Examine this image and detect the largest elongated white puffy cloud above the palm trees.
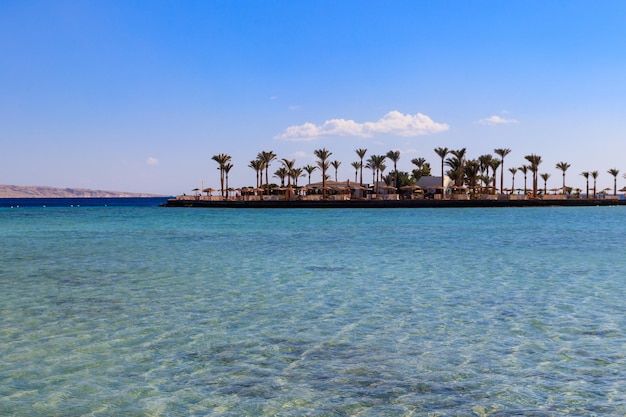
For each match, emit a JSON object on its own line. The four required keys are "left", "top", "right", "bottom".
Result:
{"left": 274, "top": 110, "right": 448, "bottom": 141}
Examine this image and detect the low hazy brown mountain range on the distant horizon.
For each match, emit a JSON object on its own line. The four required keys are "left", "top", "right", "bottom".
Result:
{"left": 0, "top": 184, "right": 163, "bottom": 198}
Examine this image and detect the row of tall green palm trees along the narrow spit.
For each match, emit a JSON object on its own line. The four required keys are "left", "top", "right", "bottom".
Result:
{"left": 211, "top": 147, "right": 626, "bottom": 198}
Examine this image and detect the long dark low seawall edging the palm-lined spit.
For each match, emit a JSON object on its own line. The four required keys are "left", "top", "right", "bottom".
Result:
{"left": 161, "top": 198, "right": 626, "bottom": 209}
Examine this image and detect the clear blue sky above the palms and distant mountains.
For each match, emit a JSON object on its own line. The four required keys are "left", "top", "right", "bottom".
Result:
{"left": 0, "top": 0, "right": 626, "bottom": 194}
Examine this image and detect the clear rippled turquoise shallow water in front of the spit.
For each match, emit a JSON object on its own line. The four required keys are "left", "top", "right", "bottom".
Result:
{"left": 0, "top": 203, "right": 626, "bottom": 416}
